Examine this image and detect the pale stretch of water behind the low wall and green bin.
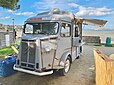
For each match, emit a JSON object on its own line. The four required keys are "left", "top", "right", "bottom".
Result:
{"left": 82, "top": 30, "right": 114, "bottom": 44}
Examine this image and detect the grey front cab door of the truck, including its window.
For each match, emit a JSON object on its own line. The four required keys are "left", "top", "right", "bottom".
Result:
{"left": 56, "top": 23, "right": 71, "bottom": 59}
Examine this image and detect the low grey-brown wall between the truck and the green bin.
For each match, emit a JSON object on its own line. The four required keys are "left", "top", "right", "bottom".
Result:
{"left": 82, "top": 36, "right": 100, "bottom": 43}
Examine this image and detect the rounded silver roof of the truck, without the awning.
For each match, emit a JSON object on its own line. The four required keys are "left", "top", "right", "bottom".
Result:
{"left": 27, "top": 9, "right": 75, "bottom": 22}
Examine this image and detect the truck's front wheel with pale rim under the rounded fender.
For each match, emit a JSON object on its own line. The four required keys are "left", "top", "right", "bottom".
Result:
{"left": 59, "top": 57, "right": 71, "bottom": 76}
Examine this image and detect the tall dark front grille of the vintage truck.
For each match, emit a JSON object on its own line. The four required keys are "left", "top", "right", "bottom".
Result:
{"left": 21, "top": 40, "right": 36, "bottom": 67}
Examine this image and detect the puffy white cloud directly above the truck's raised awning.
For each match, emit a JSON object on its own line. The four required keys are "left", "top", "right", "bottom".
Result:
{"left": 76, "top": 6, "right": 112, "bottom": 16}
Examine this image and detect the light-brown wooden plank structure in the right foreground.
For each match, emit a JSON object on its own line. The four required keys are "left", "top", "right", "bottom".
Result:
{"left": 94, "top": 49, "right": 114, "bottom": 85}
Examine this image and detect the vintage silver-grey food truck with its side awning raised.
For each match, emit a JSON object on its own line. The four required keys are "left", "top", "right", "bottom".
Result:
{"left": 14, "top": 9, "right": 107, "bottom": 76}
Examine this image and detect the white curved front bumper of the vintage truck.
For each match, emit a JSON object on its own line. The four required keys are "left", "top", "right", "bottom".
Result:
{"left": 13, "top": 65, "right": 53, "bottom": 76}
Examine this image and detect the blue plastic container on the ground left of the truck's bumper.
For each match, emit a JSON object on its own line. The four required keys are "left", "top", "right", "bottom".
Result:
{"left": 0, "top": 57, "right": 16, "bottom": 77}
